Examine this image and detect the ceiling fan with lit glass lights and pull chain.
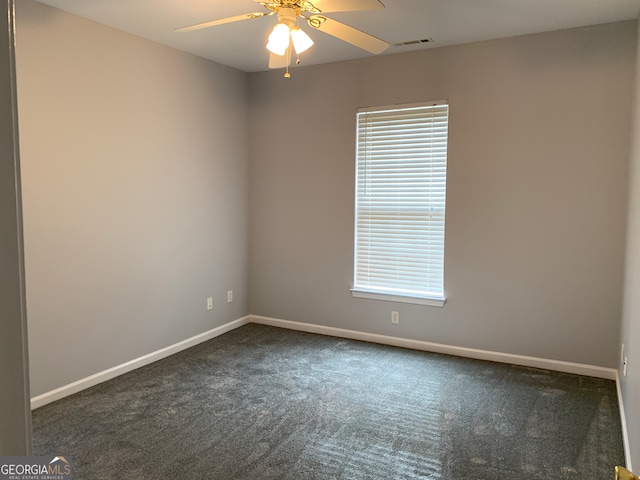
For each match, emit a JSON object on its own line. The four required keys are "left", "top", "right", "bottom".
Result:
{"left": 176, "top": 0, "right": 389, "bottom": 78}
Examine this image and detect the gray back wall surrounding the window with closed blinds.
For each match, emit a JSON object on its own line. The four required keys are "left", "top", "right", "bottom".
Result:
{"left": 249, "top": 21, "right": 636, "bottom": 368}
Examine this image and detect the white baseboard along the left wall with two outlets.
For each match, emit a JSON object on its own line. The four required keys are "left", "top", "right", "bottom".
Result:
{"left": 31, "top": 316, "right": 250, "bottom": 410}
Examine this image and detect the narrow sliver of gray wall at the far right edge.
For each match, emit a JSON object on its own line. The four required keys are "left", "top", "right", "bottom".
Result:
{"left": 620, "top": 21, "right": 640, "bottom": 474}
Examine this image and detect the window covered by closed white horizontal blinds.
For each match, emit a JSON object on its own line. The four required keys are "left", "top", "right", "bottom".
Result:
{"left": 352, "top": 102, "right": 449, "bottom": 306}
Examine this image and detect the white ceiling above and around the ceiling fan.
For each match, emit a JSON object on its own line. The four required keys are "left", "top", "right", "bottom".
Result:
{"left": 33, "top": 0, "right": 640, "bottom": 72}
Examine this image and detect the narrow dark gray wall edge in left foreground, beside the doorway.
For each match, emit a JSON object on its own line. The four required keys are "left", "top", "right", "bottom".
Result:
{"left": 0, "top": 0, "right": 31, "bottom": 456}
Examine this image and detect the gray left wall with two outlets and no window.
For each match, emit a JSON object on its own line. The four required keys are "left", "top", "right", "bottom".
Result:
{"left": 17, "top": 0, "right": 248, "bottom": 396}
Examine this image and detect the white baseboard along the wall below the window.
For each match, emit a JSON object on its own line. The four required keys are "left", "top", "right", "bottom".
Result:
{"left": 250, "top": 315, "right": 617, "bottom": 380}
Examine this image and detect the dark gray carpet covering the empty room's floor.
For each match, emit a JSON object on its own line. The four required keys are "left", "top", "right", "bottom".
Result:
{"left": 33, "top": 324, "right": 624, "bottom": 480}
